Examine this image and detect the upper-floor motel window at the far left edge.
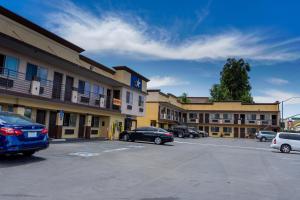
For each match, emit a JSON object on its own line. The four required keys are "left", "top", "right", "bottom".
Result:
{"left": 0, "top": 54, "right": 19, "bottom": 78}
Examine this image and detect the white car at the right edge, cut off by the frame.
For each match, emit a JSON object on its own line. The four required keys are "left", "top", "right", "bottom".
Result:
{"left": 271, "top": 132, "right": 300, "bottom": 153}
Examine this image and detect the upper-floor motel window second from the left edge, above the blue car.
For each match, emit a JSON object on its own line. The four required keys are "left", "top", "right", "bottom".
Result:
{"left": 25, "top": 63, "right": 48, "bottom": 85}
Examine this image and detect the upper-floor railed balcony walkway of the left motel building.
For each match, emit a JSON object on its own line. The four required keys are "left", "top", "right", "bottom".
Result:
{"left": 0, "top": 68, "right": 120, "bottom": 111}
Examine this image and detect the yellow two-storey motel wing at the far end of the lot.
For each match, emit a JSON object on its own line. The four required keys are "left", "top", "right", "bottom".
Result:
{"left": 137, "top": 90, "right": 280, "bottom": 138}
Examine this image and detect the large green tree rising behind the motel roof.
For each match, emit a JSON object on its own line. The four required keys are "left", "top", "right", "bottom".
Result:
{"left": 210, "top": 58, "right": 253, "bottom": 103}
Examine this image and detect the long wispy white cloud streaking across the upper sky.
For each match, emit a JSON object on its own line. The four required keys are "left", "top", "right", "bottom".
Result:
{"left": 47, "top": 2, "right": 300, "bottom": 61}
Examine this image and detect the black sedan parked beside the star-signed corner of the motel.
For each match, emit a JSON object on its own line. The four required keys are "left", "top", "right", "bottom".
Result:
{"left": 119, "top": 127, "right": 174, "bottom": 144}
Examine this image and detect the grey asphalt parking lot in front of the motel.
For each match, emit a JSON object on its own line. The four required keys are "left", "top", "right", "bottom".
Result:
{"left": 0, "top": 138, "right": 300, "bottom": 200}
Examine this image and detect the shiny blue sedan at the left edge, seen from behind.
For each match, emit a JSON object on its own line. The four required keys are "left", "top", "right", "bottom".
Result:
{"left": 0, "top": 112, "right": 49, "bottom": 156}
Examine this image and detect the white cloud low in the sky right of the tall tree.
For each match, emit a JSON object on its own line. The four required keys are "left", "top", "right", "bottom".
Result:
{"left": 253, "top": 89, "right": 300, "bottom": 104}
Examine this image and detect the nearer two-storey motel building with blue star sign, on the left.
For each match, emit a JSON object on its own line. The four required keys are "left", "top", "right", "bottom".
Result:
{"left": 0, "top": 6, "right": 149, "bottom": 139}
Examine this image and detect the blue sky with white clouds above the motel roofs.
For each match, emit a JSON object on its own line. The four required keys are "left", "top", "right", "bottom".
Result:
{"left": 0, "top": 0, "right": 300, "bottom": 116}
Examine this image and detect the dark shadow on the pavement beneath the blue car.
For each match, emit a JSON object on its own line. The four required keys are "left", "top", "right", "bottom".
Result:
{"left": 0, "top": 154, "right": 46, "bottom": 168}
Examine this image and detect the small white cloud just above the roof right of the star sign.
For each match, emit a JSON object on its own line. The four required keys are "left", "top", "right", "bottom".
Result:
{"left": 147, "top": 76, "right": 189, "bottom": 88}
